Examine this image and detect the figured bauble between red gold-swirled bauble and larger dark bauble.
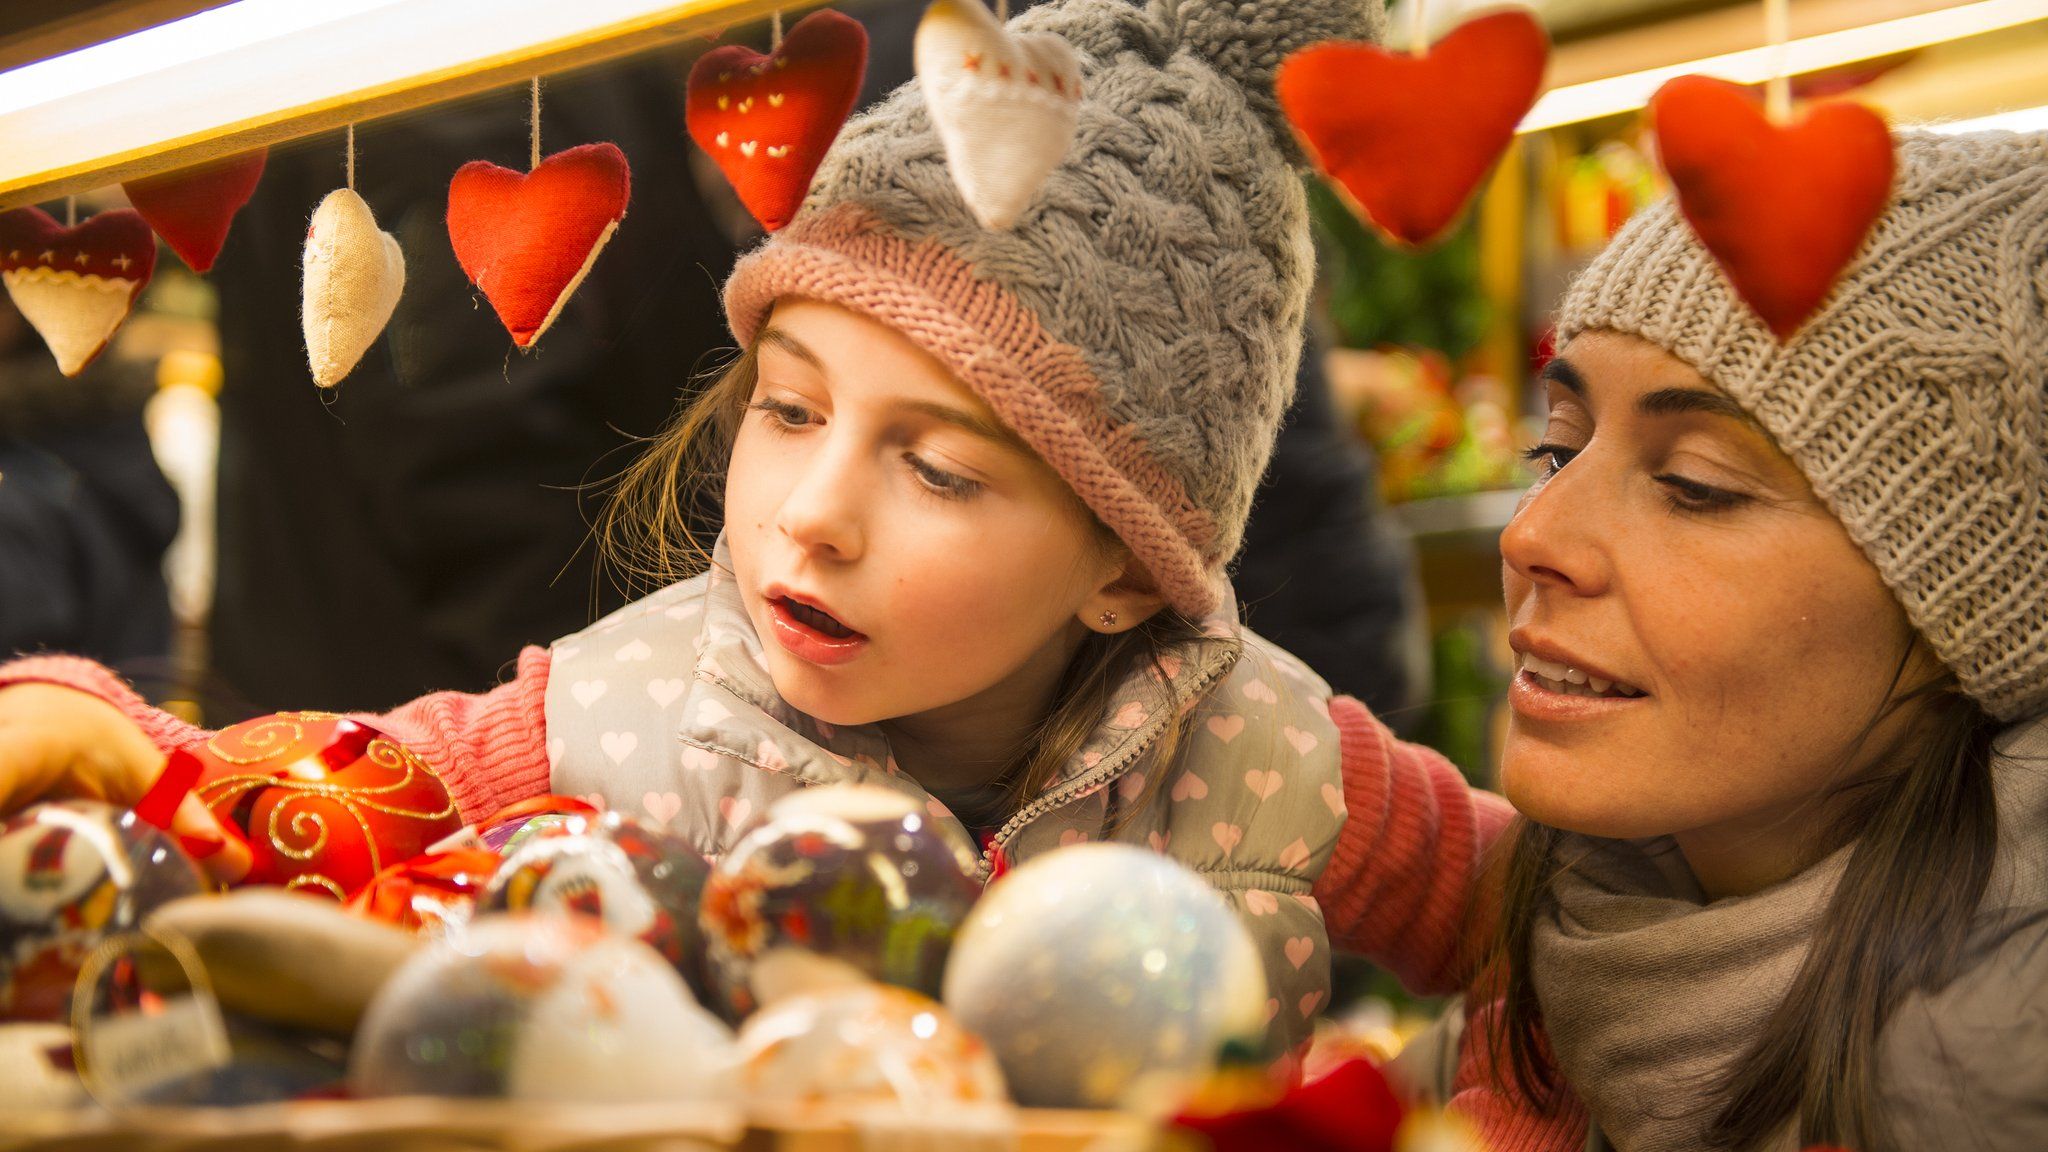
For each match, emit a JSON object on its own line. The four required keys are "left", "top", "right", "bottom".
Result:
{"left": 477, "top": 812, "right": 711, "bottom": 994}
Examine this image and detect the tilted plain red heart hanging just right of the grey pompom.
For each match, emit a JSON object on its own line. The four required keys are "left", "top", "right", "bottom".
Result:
{"left": 1274, "top": 8, "right": 1550, "bottom": 246}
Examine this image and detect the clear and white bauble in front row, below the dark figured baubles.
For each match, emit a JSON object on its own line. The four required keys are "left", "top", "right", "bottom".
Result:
{"left": 348, "top": 916, "right": 735, "bottom": 1103}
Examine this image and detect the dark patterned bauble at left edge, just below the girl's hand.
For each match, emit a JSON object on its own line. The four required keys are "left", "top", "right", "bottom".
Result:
{"left": 0, "top": 799, "right": 207, "bottom": 1021}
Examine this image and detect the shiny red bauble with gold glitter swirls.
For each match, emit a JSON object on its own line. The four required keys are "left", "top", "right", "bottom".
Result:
{"left": 166, "top": 711, "right": 463, "bottom": 900}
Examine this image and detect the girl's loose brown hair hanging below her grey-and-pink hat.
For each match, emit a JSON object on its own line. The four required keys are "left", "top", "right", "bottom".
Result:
{"left": 596, "top": 348, "right": 1228, "bottom": 828}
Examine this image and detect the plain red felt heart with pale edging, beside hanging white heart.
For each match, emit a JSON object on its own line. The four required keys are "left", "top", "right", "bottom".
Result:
{"left": 449, "top": 143, "right": 633, "bottom": 348}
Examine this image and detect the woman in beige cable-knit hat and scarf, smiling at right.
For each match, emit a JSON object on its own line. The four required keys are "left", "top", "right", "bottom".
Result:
{"left": 1317, "top": 133, "right": 2048, "bottom": 1152}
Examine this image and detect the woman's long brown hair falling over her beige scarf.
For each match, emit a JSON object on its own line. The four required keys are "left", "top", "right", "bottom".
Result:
{"left": 1481, "top": 648, "right": 1999, "bottom": 1152}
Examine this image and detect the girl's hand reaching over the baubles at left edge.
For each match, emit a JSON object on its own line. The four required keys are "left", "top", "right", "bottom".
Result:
{"left": 0, "top": 685, "right": 250, "bottom": 883}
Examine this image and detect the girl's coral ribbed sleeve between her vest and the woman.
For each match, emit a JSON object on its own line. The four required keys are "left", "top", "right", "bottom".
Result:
{"left": 1315, "top": 697, "right": 1513, "bottom": 994}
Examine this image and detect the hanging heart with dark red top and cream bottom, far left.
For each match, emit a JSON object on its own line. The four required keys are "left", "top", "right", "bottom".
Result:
{"left": 0, "top": 207, "right": 156, "bottom": 375}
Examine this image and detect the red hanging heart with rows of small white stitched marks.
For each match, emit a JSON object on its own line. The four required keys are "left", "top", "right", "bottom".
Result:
{"left": 684, "top": 8, "right": 868, "bottom": 232}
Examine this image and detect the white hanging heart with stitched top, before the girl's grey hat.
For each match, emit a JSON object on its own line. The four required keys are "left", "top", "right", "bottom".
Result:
{"left": 915, "top": 0, "right": 1081, "bottom": 228}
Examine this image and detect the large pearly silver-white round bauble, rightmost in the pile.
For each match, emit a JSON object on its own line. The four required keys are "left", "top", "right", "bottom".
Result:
{"left": 946, "top": 845, "right": 1266, "bottom": 1107}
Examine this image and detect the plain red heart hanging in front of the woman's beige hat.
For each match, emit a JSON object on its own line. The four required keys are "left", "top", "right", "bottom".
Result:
{"left": 1651, "top": 76, "right": 1896, "bottom": 340}
